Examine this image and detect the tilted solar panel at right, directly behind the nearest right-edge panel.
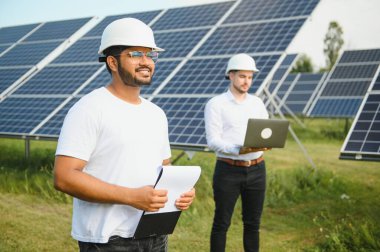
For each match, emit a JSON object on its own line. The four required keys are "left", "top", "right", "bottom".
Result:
{"left": 307, "top": 49, "right": 380, "bottom": 117}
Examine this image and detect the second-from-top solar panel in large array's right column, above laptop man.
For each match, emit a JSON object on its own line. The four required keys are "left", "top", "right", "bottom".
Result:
{"left": 196, "top": 19, "right": 305, "bottom": 55}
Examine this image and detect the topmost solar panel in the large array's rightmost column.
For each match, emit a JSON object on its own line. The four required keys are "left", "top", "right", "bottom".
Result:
{"left": 224, "top": 0, "right": 319, "bottom": 23}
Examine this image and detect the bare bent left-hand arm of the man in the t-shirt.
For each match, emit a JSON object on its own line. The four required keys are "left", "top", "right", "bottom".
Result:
{"left": 54, "top": 155, "right": 167, "bottom": 212}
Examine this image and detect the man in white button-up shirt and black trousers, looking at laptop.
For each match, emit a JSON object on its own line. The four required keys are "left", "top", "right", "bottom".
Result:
{"left": 205, "top": 54, "right": 268, "bottom": 252}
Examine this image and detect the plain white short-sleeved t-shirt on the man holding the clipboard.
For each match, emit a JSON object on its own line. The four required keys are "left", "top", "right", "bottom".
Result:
{"left": 56, "top": 87, "right": 171, "bottom": 243}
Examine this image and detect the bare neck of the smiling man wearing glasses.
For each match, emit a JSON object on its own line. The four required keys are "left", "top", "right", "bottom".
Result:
{"left": 107, "top": 82, "right": 141, "bottom": 105}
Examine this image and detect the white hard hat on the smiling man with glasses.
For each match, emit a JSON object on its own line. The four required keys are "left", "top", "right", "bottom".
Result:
{"left": 98, "top": 18, "right": 164, "bottom": 55}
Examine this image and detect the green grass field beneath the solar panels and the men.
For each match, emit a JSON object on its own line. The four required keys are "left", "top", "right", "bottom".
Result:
{"left": 0, "top": 119, "right": 380, "bottom": 252}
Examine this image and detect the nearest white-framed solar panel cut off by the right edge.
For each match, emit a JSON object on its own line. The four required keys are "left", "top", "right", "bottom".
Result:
{"left": 339, "top": 72, "right": 380, "bottom": 161}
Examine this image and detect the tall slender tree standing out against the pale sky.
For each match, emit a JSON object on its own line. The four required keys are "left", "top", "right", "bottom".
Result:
{"left": 323, "top": 21, "right": 344, "bottom": 71}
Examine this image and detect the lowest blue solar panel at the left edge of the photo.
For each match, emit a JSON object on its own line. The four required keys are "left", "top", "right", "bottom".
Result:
{"left": 0, "top": 97, "right": 64, "bottom": 134}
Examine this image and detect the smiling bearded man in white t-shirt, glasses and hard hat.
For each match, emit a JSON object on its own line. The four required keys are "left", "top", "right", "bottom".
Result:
{"left": 54, "top": 18, "right": 195, "bottom": 251}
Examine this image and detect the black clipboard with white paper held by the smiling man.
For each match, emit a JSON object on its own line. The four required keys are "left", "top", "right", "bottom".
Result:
{"left": 133, "top": 166, "right": 201, "bottom": 239}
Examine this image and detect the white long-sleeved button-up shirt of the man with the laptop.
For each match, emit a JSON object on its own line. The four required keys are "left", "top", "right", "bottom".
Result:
{"left": 205, "top": 87, "right": 269, "bottom": 160}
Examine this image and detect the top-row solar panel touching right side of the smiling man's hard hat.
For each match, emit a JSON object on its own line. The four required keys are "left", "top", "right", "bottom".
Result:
{"left": 153, "top": 2, "right": 234, "bottom": 31}
